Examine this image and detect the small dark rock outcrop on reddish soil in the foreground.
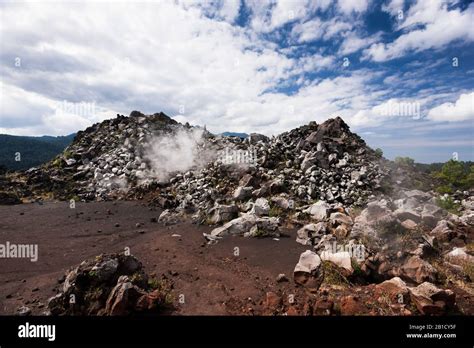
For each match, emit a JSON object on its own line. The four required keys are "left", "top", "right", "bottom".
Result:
{"left": 48, "top": 254, "right": 171, "bottom": 315}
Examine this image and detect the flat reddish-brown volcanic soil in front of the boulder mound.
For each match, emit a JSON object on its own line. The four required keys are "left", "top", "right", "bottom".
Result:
{"left": 0, "top": 201, "right": 306, "bottom": 315}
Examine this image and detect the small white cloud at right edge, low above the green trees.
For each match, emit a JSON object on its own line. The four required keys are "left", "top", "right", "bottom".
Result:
{"left": 428, "top": 92, "right": 474, "bottom": 122}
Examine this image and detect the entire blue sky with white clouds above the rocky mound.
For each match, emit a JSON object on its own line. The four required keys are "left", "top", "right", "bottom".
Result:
{"left": 0, "top": 0, "right": 474, "bottom": 162}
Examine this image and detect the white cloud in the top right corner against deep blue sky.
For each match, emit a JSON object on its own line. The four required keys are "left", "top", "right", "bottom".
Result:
{"left": 364, "top": 0, "right": 474, "bottom": 62}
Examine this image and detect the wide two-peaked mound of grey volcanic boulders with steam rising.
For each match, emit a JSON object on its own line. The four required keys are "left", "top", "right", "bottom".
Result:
{"left": 2, "top": 111, "right": 386, "bottom": 211}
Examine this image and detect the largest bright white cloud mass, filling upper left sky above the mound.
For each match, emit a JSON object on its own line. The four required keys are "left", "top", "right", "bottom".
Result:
{"left": 0, "top": 2, "right": 362, "bottom": 135}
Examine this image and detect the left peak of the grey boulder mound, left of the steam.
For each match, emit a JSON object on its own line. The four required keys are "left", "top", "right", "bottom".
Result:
{"left": 22, "top": 111, "right": 185, "bottom": 200}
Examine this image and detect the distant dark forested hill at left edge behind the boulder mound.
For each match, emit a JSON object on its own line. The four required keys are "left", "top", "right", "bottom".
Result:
{"left": 0, "top": 134, "right": 75, "bottom": 170}
